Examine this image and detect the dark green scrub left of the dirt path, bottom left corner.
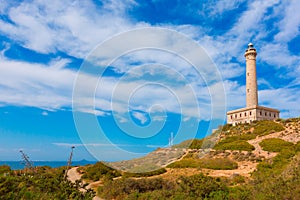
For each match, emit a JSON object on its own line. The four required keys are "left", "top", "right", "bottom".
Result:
{"left": 0, "top": 166, "right": 95, "bottom": 200}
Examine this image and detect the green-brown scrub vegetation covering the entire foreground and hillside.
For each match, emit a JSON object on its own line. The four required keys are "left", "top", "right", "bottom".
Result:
{"left": 0, "top": 118, "right": 300, "bottom": 200}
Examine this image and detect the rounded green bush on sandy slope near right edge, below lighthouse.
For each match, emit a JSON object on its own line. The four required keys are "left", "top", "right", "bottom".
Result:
{"left": 259, "top": 138, "right": 293, "bottom": 152}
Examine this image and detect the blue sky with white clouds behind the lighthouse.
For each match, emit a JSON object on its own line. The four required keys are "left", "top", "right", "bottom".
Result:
{"left": 0, "top": 0, "right": 300, "bottom": 160}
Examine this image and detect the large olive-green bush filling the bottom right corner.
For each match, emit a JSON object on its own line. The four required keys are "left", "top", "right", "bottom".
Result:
{"left": 249, "top": 150, "right": 300, "bottom": 199}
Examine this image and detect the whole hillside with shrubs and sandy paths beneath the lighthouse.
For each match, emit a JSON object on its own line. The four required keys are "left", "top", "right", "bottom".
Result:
{"left": 80, "top": 118, "right": 300, "bottom": 199}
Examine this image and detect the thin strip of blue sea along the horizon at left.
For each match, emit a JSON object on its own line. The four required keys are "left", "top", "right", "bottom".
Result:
{"left": 0, "top": 160, "right": 96, "bottom": 170}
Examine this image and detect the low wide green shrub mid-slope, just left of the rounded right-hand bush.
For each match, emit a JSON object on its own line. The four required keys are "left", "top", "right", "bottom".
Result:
{"left": 214, "top": 140, "right": 255, "bottom": 151}
